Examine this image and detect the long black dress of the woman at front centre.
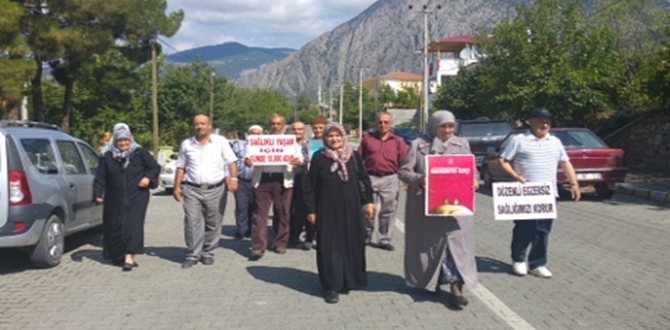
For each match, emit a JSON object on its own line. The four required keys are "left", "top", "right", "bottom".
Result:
{"left": 303, "top": 152, "right": 372, "bottom": 292}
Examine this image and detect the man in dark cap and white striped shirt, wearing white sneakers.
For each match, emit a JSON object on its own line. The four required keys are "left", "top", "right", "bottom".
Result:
{"left": 499, "top": 108, "right": 581, "bottom": 278}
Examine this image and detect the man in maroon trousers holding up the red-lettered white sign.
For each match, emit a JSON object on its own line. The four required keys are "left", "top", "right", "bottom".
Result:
{"left": 244, "top": 114, "right": 303, "bottom": 260}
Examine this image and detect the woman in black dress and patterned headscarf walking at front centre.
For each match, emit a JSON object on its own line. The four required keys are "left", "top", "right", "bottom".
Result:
{"left": 303, "top": 123, "right": 374, "bottom": 304}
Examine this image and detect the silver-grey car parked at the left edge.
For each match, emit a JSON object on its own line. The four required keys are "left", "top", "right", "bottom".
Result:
{"left": 0, "top": 121, "right": 102, "bottom": 267}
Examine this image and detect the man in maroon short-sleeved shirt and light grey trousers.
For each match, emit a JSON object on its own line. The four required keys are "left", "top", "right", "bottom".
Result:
{"left": 358, "top": 112, "right": 407, "bottom": 251}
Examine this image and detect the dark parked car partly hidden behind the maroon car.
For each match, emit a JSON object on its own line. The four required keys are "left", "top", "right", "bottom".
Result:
{"left": 454, "top": 117, "right": 514, "bottom": 170}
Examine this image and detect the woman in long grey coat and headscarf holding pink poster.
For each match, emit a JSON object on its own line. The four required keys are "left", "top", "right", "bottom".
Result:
{"left": 399, "top": 110, "right": 479, "bottom": 306}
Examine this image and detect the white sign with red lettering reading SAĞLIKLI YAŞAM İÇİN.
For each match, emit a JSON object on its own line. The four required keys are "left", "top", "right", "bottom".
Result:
{"left": 247, "top": 135, "right": 298, "bottom": 166}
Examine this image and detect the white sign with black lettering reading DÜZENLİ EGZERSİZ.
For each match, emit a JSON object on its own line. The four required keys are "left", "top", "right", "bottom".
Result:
{"left": 492, "top": 182, "right": 556, "bottom": 220}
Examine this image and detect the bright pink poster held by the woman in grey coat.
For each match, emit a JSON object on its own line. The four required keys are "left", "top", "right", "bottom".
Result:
{"left": 425, "top": 155, "right": 475, "bottom": 217}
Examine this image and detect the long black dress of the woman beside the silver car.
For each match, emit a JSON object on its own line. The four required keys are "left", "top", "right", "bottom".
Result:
{"left": 94, "top": 148, "right": 160, "bottom": 261}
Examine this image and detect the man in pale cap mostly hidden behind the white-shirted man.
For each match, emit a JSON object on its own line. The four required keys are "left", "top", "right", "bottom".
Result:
{"left": 230, "top": 125, "right": 263, "bottom": 239}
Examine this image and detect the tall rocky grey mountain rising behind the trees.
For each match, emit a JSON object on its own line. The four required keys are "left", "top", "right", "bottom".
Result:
{"left": 238, "top": 0, "right": 532, "bottom": 95}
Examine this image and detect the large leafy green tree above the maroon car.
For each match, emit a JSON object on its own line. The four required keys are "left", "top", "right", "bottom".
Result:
{"left": 478, "top": 0, "right": 623, "bottom": 123}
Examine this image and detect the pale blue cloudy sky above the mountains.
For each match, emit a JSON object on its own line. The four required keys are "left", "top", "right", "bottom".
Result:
{"left": 161, "top": 0, "right": 376, "bottom": 53}
